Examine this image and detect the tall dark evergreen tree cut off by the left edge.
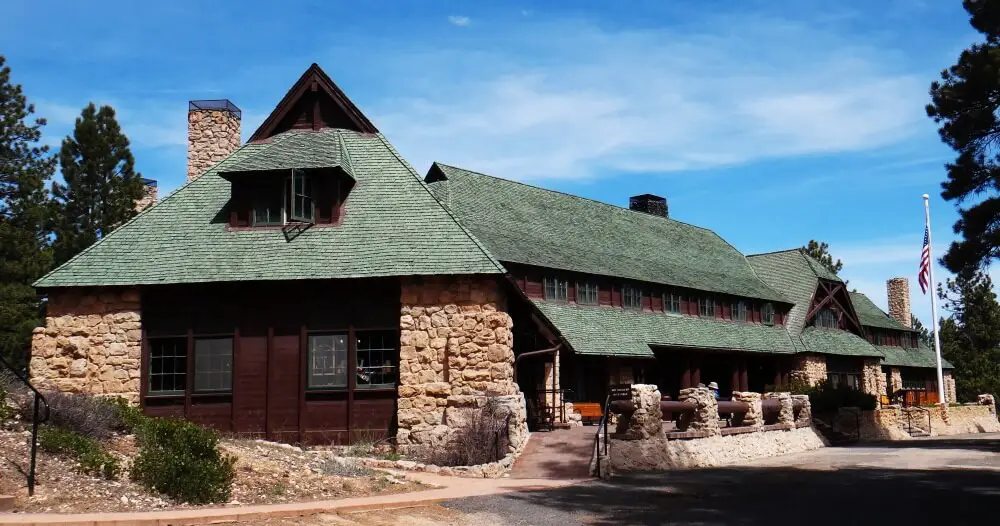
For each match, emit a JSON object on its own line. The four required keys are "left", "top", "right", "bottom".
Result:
{"left": 0, "top": 55, "right": 55, "bottom": 366}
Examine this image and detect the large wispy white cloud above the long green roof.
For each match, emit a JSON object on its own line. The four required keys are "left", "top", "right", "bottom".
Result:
{"left": 372, "top": 19, "right": 926, "bottom": 179}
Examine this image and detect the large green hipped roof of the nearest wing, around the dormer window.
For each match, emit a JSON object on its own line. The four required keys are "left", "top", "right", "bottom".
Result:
{"left": 35, "top": 129, "right": 503, "bottom": 287}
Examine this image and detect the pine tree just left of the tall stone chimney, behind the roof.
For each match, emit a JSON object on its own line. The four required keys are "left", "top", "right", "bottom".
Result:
{"left": 52, "top": 103, "right": 144, "bottom": 264}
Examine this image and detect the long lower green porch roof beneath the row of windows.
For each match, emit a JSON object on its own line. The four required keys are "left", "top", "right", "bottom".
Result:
{"left": 534, "top": 301, "right": 795, "bottom": 357}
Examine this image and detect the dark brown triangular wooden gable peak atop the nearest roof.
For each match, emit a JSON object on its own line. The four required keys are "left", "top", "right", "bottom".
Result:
{"left": 250, "top": 62, "right": 378, "bottom": 142}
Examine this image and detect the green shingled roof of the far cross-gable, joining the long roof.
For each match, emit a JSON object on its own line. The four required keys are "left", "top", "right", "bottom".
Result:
{"left": 747, "top": 249, "right": 840, "bottom": 334}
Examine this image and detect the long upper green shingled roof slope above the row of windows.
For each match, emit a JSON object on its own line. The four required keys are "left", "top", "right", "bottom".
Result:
{"left": 427, "top": 163, "right": 789, "bottom": 303}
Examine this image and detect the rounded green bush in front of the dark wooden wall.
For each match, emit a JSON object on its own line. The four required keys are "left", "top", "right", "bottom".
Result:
{"left": 131, "top": 418, "right": 236, "bottom": 504}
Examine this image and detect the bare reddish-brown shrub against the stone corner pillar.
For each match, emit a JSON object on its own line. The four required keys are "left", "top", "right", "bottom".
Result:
{"left": 417, "top": 398, "right": 509, "bottom": 466}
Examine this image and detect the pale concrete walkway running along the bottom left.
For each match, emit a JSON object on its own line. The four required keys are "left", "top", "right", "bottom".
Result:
{"left": 0, "top": 473, "right": 575, "bottom": 526}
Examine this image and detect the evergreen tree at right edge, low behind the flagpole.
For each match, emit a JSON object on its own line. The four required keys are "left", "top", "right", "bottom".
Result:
{"left": 938, "top": 271, "right": 1000, "bottom": 401}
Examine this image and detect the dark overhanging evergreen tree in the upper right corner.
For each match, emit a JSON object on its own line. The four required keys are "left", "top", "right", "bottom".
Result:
{"left": 927, "top": 0, "right": 1000, "bottom": 273}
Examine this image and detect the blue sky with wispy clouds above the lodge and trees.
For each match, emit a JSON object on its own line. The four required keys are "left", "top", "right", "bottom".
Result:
{"left": 0, "top": 0, "right": 977, "bottom": 321}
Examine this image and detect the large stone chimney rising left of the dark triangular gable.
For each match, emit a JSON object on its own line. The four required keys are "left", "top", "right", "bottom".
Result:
{"left": 188, "top": 99, "right": 242, "bottom": 182}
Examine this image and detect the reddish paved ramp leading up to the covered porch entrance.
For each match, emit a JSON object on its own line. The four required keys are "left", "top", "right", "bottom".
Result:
{"left": 510, "top": 426, "right": 597, "bottom": 480}
